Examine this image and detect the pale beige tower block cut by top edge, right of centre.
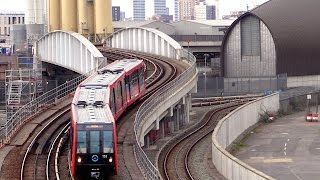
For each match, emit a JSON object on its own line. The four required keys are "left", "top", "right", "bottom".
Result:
{"left": 179, "top": 0, "right": 195, "bottom": 20}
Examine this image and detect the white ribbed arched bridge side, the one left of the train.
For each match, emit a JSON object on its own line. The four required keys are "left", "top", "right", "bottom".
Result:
{"left": 35, "top": 31, "right": 103, "bottom": 74}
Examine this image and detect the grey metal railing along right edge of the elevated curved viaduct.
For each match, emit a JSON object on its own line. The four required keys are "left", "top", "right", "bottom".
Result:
{"left": 134, "top": 49, "right": 197, "bottom": 179}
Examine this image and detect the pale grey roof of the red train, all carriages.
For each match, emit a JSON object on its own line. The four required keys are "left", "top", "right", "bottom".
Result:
{"left": 73, "top": 59, "right": 142, "bottom": 123}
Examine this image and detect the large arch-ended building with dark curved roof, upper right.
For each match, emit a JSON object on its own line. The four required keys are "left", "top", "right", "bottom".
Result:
{"left": 221, "top": 0, "right": 320, "bottom": 88}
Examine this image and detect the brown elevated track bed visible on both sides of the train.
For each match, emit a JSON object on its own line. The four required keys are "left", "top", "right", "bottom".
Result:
{"left": 1, "top": 47, "right": 190, "bottom": 180}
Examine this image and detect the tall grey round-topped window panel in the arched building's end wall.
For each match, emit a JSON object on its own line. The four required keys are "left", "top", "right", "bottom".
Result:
{"left": 241, "top": 16, "right": 261, "bottom": 56}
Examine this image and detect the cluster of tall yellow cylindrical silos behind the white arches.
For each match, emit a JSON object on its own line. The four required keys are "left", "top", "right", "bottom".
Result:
{"left": 48, "top": 0, "right": 113, "bottom": 41}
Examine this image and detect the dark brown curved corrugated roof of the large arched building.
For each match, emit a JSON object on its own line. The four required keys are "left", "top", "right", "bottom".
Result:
{"left": 250, "top": 0, "right": 320, "bottom": 76}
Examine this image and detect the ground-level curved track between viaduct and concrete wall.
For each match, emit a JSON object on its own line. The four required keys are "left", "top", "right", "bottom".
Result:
{"left": 158, "top": 103, "right": 242, "bottom": 180}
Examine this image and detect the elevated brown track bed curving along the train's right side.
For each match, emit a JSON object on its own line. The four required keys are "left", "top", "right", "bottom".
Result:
{"left": 100, "top": 49, "right": 183, "bottom": 179}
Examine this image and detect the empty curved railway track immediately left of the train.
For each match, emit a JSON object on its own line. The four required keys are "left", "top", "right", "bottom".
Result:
{"left": 20, "top": 108, "right": 70, "bottom": 180}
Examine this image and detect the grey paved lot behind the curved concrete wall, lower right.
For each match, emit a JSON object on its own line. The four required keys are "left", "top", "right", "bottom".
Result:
{"left": 235, "top": 109, "right": 320, "bottom": 180}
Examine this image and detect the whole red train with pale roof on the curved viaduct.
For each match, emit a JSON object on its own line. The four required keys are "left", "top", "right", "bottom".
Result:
{"left": 70, "top": 59, "right": 146, "bottom": 179}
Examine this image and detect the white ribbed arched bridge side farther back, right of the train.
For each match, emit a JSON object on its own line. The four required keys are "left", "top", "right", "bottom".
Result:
{"left": 107, "top": 27, "right": 182, "bottom": 59}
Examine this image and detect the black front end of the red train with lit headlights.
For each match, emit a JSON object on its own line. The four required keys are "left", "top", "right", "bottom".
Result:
{"left": 75, "top": 123, "right": 118, "bottom": 179}
